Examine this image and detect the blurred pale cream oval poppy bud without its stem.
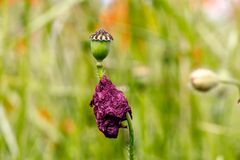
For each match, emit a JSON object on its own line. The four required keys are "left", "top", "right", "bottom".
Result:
{"left": 190, "top": 69, "right": 219, "bottom": 92}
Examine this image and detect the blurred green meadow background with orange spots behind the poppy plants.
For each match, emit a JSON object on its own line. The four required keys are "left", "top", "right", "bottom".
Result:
{"left": 0, "top": 0, "right": 240, "bottom": 160}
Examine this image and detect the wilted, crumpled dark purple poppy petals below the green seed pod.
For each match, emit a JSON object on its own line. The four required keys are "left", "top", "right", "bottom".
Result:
{"left": 90, "top": 75, "right": 132, "bottom": 138}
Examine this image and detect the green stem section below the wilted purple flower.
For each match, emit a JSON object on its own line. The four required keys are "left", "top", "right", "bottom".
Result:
{"left": 126, "top": 112, "right": 134, "bottom": 160}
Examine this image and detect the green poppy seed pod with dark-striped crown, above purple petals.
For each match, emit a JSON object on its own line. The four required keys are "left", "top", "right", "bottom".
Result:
{"left": 90, "top": 29, "right": 113, "bottom": 62}
